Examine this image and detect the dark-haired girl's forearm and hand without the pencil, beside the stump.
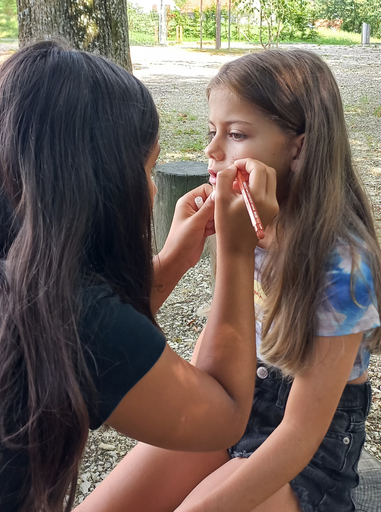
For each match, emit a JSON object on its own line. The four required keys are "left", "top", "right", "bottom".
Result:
{"left": 151, "top": 184, "right": 214, "bottom": 314}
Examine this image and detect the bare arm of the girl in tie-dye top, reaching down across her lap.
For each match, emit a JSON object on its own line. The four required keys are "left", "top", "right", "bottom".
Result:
{"left": 176, "top": 333, "right": 363, "bottom": 512}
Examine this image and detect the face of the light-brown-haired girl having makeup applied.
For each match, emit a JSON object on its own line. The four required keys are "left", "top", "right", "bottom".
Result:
{"left": 205, "top": 86, "right": 300, "bottom": 197}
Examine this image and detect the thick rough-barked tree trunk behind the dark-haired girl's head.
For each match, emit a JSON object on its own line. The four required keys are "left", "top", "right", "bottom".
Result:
{"left": 17, "top": 0, "right": 132, "bottom": 71}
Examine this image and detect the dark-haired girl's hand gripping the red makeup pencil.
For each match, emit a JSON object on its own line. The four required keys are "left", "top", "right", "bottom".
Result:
{"left": 215, "top": 158, "right": 279, "bottom": 251}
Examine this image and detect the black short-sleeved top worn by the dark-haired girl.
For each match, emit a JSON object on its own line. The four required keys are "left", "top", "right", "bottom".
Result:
{"left": 0, "top": 287, "right": 165, "bottom": 512}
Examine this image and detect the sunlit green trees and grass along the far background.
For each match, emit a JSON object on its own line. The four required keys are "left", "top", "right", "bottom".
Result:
{"left": 0, "top": 0, "right": 381, "bottom": 45}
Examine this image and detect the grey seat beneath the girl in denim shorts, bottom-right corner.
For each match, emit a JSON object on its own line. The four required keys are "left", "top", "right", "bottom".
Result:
{"left": 353, "top": 450, "right": 381, "bottom": 512}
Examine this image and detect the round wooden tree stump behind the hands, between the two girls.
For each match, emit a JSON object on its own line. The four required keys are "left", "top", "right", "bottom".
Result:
{"left": 153, "top": 162, "right": 209, "bottom": 252}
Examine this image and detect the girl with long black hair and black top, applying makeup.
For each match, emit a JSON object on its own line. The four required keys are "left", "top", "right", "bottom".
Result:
{"left": 0, "top": 41, "right": 278, "bottom": 512}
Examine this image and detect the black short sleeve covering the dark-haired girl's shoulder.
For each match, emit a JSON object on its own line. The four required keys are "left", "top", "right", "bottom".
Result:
{"left": 79, "top": 284, "right": 166, "bottom": 429}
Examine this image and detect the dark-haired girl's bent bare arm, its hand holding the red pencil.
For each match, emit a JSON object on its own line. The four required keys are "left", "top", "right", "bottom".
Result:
{"left": 106, "top": 164, "right": 278, "bottom": 451}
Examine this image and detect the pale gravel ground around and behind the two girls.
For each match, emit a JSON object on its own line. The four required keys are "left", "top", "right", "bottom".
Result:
{"left": 0, "top": 40, "right": 381, "bottom": 502}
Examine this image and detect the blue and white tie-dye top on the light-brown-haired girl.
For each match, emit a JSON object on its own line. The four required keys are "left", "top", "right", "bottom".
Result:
{"left": 254, "top": 244, "right": 381, "bottom": 380}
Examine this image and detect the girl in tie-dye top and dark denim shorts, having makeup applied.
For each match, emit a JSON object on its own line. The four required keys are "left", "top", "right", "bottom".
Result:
{"left": 80, "top": 50, "right": 381, "bottom": 512}
